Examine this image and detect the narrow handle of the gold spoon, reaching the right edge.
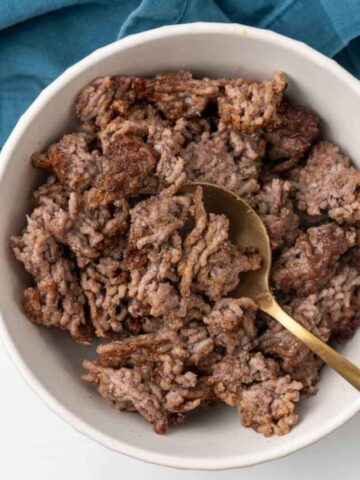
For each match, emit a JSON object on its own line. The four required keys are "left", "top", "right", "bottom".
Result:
{"left": 258, "top": 295, "right": 360, "bottom": 391}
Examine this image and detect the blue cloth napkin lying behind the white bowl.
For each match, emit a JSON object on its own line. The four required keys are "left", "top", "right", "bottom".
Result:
{"left": 0, "top": 0, "right": 360, "bottom": 147}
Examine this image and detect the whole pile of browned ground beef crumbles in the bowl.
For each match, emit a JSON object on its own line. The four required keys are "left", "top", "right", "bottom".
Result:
{"left": 11, "top": 72, "right": 360, "bottom": 435}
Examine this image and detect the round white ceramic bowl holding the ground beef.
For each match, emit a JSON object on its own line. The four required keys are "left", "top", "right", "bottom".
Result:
{"left": 0, "top": 23, "right": 360, "bottom": 470}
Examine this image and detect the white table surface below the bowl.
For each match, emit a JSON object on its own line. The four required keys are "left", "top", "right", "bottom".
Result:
{"left": 0, "top": 344, "right": 360, "bottom": 480}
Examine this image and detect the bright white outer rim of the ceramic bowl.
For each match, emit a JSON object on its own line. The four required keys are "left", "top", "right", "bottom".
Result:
{"left": 0, "top": 22, "right": 360, "bottom": 470}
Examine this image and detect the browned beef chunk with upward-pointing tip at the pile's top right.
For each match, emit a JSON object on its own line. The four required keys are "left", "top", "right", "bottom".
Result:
{"left": 218, "top": 72, "right": 287, "bottom": 133}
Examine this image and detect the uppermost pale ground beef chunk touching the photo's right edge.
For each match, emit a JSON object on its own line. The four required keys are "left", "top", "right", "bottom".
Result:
{"left": 297, "top": 142, "right": 360, "bottom": 224}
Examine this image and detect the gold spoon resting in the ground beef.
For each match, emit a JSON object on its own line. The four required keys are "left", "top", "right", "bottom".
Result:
{"left": 183, "top": 182, "right": 360, "bottom": 390}
